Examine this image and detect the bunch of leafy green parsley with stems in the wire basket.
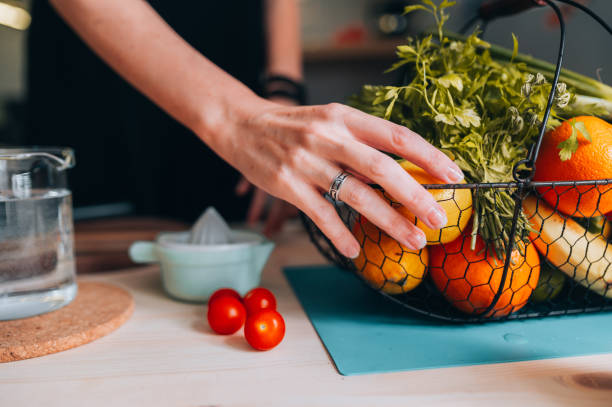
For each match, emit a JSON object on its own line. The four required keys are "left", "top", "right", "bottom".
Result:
{"left": 351, "top": 0, "right": 573, "bottom": 254}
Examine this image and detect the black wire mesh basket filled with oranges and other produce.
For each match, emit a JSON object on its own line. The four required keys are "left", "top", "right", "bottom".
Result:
{"left": 302, "top": 0, "right": 612, "bottom": 322}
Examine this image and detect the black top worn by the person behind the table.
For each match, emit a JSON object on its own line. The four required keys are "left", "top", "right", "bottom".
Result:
{"left": 27, "top": 0, "right": 265, "bottom": 221}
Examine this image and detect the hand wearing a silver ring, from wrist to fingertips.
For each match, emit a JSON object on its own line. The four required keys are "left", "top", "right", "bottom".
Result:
{"left": 206, "top": 99, "right": 463, "bottom": 258}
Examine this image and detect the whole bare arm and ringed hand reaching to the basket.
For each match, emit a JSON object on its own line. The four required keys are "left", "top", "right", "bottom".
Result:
{"left": 52, "top": 0, "right": 463, "bottom": 258}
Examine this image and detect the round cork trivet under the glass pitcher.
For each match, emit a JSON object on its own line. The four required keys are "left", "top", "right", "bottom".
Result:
{"left": 0, "top": 282, "right": 134, "bottom": 362}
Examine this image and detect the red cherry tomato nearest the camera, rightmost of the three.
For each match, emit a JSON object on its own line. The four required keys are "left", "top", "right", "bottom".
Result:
{"left": 244, "top": 309, "right": 285, "bottom": 350}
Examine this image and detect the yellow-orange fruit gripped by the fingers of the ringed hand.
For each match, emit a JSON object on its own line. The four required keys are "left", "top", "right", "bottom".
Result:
{"left": 379, "top": 160, "right": 472, "bottom": 245}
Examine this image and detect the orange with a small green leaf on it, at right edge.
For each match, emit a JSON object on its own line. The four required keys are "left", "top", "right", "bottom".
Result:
{"left": 534, "top": 116, "right": 612, "bottom": 217}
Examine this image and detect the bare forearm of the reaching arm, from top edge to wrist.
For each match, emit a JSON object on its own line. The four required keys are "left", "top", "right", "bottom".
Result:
{"left": 51, "top": 0, "right": 257, "bottom": 144}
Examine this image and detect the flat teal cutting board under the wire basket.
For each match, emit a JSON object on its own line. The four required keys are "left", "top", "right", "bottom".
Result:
{"left": 285, "top": 266, "right": 612, "bottom": 376}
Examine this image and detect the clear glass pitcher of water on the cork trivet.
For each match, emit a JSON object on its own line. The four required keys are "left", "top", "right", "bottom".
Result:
{"left": 0, "top": 148, "right": 77, "bottom": 320}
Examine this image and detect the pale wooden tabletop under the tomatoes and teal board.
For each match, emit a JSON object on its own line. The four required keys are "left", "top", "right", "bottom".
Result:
{"left": 0, "top": 228, "right": 612, "bottom": 407}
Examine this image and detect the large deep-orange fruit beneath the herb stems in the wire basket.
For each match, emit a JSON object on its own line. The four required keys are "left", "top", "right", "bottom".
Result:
{"left": 429, "top": 233, "right": 540, "bottom": 317}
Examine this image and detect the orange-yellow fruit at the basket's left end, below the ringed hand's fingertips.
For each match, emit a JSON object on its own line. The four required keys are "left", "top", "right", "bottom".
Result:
{"left": 353, "top": 217, "right": 429, "bottom": 294}
